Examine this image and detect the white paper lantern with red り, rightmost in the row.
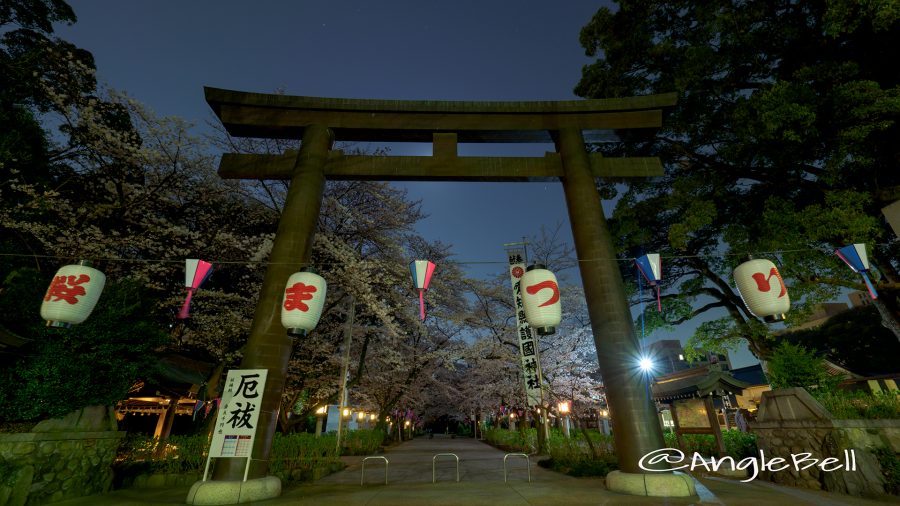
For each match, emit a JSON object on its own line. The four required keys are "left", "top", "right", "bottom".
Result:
{"left": 734, "top": 259, "right": 791, "bottom": 323}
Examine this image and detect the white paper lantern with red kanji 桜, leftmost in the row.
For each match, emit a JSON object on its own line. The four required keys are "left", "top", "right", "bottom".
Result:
{"left": 41, "top": 261, "right": 106, "bottom": 327}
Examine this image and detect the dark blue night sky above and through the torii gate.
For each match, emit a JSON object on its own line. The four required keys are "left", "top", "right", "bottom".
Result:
{"left": 58, "top": 0, "right": 760, "bottom": 365}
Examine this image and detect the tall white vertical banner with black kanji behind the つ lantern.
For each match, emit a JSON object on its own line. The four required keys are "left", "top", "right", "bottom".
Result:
{"left": 507, "top": 248, "right": 541, "bottom": 407}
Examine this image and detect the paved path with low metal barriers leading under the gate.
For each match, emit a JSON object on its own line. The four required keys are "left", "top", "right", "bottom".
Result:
{"left": 55, "top": 436, "right": 900, "bottom": 506}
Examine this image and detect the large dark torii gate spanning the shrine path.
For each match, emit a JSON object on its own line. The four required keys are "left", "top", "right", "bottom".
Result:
{"left": 197, "top": 88, "right": 688, "bottom": 502}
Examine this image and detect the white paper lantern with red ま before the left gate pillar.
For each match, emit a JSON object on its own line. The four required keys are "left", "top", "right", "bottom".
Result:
{"left": 281, "top": 267, "right": 327, "bottom": 337}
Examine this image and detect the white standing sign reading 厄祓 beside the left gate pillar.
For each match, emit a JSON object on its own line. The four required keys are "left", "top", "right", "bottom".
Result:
{"left": 203, "top": 369, "right": 269, "bottom": 481}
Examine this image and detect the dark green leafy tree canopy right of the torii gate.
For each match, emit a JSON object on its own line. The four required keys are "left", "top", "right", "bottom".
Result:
{"left": 575, "top": 0, "right": 900, "bottom": 356}
